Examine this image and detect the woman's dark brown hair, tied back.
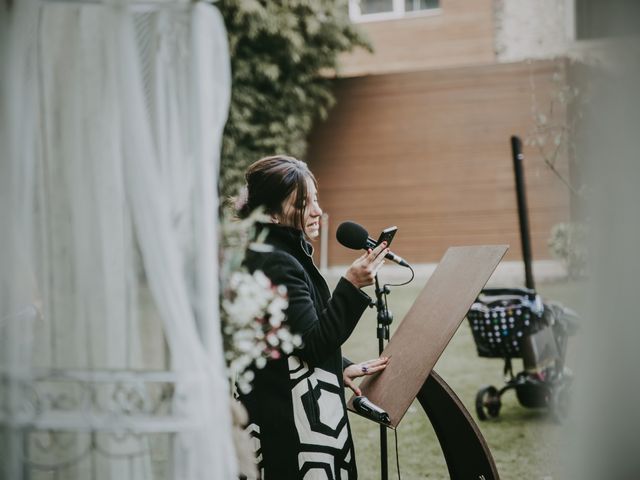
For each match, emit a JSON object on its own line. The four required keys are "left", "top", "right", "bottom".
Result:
{"left": 238, "top": 155, "right": 317, "bottom": 232}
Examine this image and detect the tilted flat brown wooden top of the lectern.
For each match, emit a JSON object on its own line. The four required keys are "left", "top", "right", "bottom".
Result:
{"left": 348, "top": 245, "right": 508, "bottom": 428}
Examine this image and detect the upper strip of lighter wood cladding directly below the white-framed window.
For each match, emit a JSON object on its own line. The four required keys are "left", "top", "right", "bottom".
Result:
{"left": 340, "top": 0, "right": 496, "bottom": 76}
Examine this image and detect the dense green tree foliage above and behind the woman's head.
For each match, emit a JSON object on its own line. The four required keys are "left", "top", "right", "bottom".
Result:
{"left": 216, "top": 0, "right": 370, "bottom": 197}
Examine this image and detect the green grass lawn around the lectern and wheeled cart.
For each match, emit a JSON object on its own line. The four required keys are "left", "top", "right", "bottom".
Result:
{"left": 343, "top": 278, "right": 581, "bottom": 480}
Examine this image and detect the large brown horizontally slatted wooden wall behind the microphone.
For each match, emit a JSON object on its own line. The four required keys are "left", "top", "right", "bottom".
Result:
{"left": 307, "top": 61, "right": 569, "bottom": 265}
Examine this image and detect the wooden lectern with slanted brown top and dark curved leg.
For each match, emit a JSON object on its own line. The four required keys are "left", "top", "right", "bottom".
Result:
{"left": 348, "top": 245, "right": 508, "bottom": 480}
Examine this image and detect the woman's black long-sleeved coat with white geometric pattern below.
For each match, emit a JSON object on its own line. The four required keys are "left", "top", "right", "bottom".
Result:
{"left": 240, "top": 225, "right": 370, "bottom": 480}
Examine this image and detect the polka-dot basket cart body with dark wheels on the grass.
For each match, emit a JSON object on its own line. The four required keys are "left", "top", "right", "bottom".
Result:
{"left": 467, "top": 288, "right": 577, "bottom": 421}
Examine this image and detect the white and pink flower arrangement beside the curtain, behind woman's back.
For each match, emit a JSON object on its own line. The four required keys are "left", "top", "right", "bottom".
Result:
{"left": 220, "top": 210, "right": 302, "bottom": 393}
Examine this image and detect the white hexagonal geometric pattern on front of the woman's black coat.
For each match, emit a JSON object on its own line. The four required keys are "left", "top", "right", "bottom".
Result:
{"left": 288, "top": 356, "right": 352, "bottom": 480}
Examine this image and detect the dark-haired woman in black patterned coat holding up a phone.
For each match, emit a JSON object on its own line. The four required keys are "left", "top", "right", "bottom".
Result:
{"left": 239, "top": 156, "right": 388, "bottom": 480}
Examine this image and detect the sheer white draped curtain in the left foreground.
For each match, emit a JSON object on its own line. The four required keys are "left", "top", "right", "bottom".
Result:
{"left": 0, "top": 0, "right": 236, "bottom": 479}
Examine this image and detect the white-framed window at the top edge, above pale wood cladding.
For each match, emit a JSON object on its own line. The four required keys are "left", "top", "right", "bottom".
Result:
{"left": 349, "top": 0, "right": 440, "bottom": 22}
